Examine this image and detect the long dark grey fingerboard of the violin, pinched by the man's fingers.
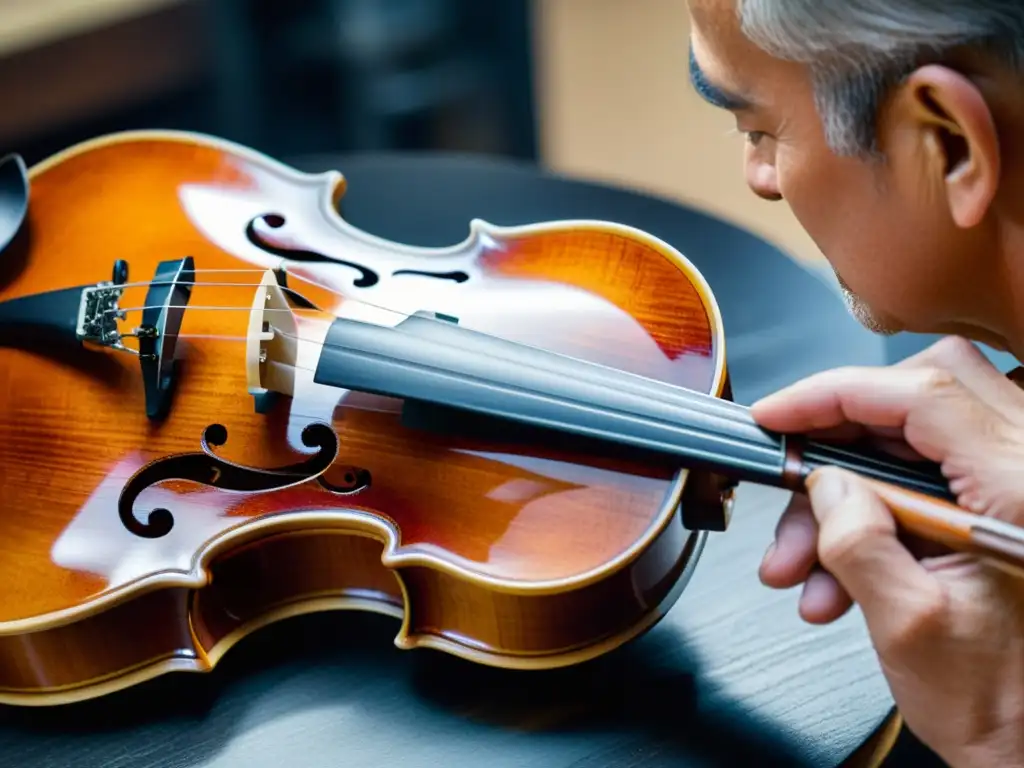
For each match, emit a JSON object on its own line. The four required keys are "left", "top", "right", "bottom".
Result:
{"left": 314, "top": 313, "right": 948, "bottom": 496}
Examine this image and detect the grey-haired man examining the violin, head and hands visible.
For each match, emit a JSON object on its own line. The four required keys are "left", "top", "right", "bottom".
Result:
{"left": 689, "top": 0, "right": 1024, "bottom": 768}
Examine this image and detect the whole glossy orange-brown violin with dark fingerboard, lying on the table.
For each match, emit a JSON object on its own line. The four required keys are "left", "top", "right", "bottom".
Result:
{"left": 0, "top": 132, "right": 1024, "bottom": 706}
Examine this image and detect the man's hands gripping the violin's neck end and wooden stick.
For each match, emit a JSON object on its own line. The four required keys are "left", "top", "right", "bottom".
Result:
{"left": 754, "top": 339, "right": 1024, "bottom": 768}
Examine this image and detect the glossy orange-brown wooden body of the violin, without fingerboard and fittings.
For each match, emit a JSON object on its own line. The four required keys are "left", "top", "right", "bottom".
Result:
{"left": 0, "top": 132, "right": 728, "bottom": 706}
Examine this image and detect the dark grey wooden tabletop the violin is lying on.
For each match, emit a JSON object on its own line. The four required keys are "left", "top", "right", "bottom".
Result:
{"left": 0, "top": 155, "right": 892, "bottom": 768}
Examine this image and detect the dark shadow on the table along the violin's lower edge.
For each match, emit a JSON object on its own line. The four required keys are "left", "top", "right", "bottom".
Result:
{"left": 0, "top": 613, "right": 813, "bottom": 768}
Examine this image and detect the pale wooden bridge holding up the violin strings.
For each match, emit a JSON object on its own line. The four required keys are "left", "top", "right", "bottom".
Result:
{"left": 246, "top": 269, "right": 299, "bottom": 413}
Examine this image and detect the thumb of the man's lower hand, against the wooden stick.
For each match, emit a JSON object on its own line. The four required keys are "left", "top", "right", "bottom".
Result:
{"left": 807, "top": 467, "right": 934, "bottom": 624}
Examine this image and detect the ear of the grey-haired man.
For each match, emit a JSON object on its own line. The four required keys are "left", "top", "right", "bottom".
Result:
{"left": 894, "top": 65, "right": 1001, "bottom": 228}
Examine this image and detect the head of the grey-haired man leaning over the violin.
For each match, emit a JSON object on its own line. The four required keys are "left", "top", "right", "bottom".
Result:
{"left": 689, "top": 0, "right": 1024, "bottom": 345}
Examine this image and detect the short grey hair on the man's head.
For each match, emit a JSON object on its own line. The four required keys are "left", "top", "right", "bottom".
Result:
{"left": 737, "top": 0, "right": 1024, "bottom": 155}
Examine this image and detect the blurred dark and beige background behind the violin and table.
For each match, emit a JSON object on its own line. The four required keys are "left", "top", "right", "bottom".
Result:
{"left": 0, "top": 0, "right": 818, "bottom": 263}
